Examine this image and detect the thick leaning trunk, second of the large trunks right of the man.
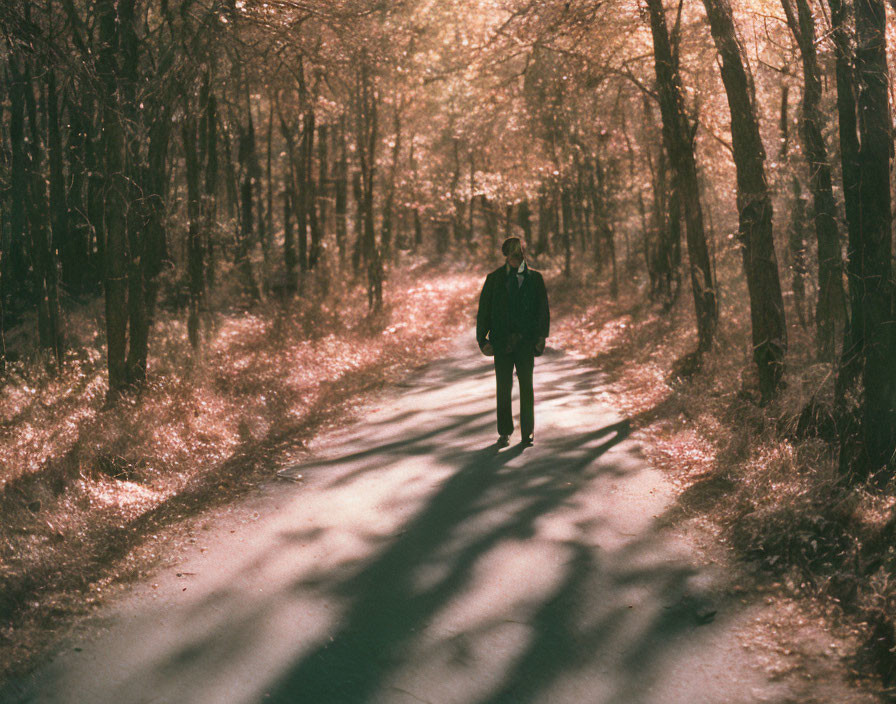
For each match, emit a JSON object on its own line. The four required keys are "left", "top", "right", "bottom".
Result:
{"left": 703, "top": 0, "right": 787, "bottom": 401}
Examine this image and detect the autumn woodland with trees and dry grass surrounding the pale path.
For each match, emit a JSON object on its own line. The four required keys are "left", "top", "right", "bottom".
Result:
{"left": 0, "top": 0, "right": 896, "bottom": 687}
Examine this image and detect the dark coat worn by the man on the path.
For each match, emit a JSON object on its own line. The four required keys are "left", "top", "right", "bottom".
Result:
{"left": 476, "top": 264, "right": 551, "bottom": 354}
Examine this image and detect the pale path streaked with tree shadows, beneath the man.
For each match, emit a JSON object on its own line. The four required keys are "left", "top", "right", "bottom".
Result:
{"left": 0, "top": 334, "right": 875, "bottom": 704}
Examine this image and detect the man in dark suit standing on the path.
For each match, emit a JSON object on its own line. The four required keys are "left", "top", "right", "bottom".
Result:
{"left": 476, "top": 237, "right": 551, "bottom": 447}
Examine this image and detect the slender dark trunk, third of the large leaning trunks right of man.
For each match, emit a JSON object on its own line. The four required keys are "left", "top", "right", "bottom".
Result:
{"left": 781, "top": 0, "right": 846, "bottom": 362}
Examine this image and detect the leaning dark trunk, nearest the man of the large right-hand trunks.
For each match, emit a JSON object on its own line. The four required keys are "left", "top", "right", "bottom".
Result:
{"left": 647, "top": 0, "right": 718, "bottom": 352}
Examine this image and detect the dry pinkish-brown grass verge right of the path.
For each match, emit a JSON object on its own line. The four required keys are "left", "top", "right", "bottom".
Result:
{"left": 552, "top": 266, "right": 896, "bottom": 687}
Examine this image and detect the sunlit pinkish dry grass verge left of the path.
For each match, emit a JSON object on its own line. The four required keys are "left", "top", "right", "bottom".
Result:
{"left": 0, "top": 262, "right": 481, "bottom": 678}
